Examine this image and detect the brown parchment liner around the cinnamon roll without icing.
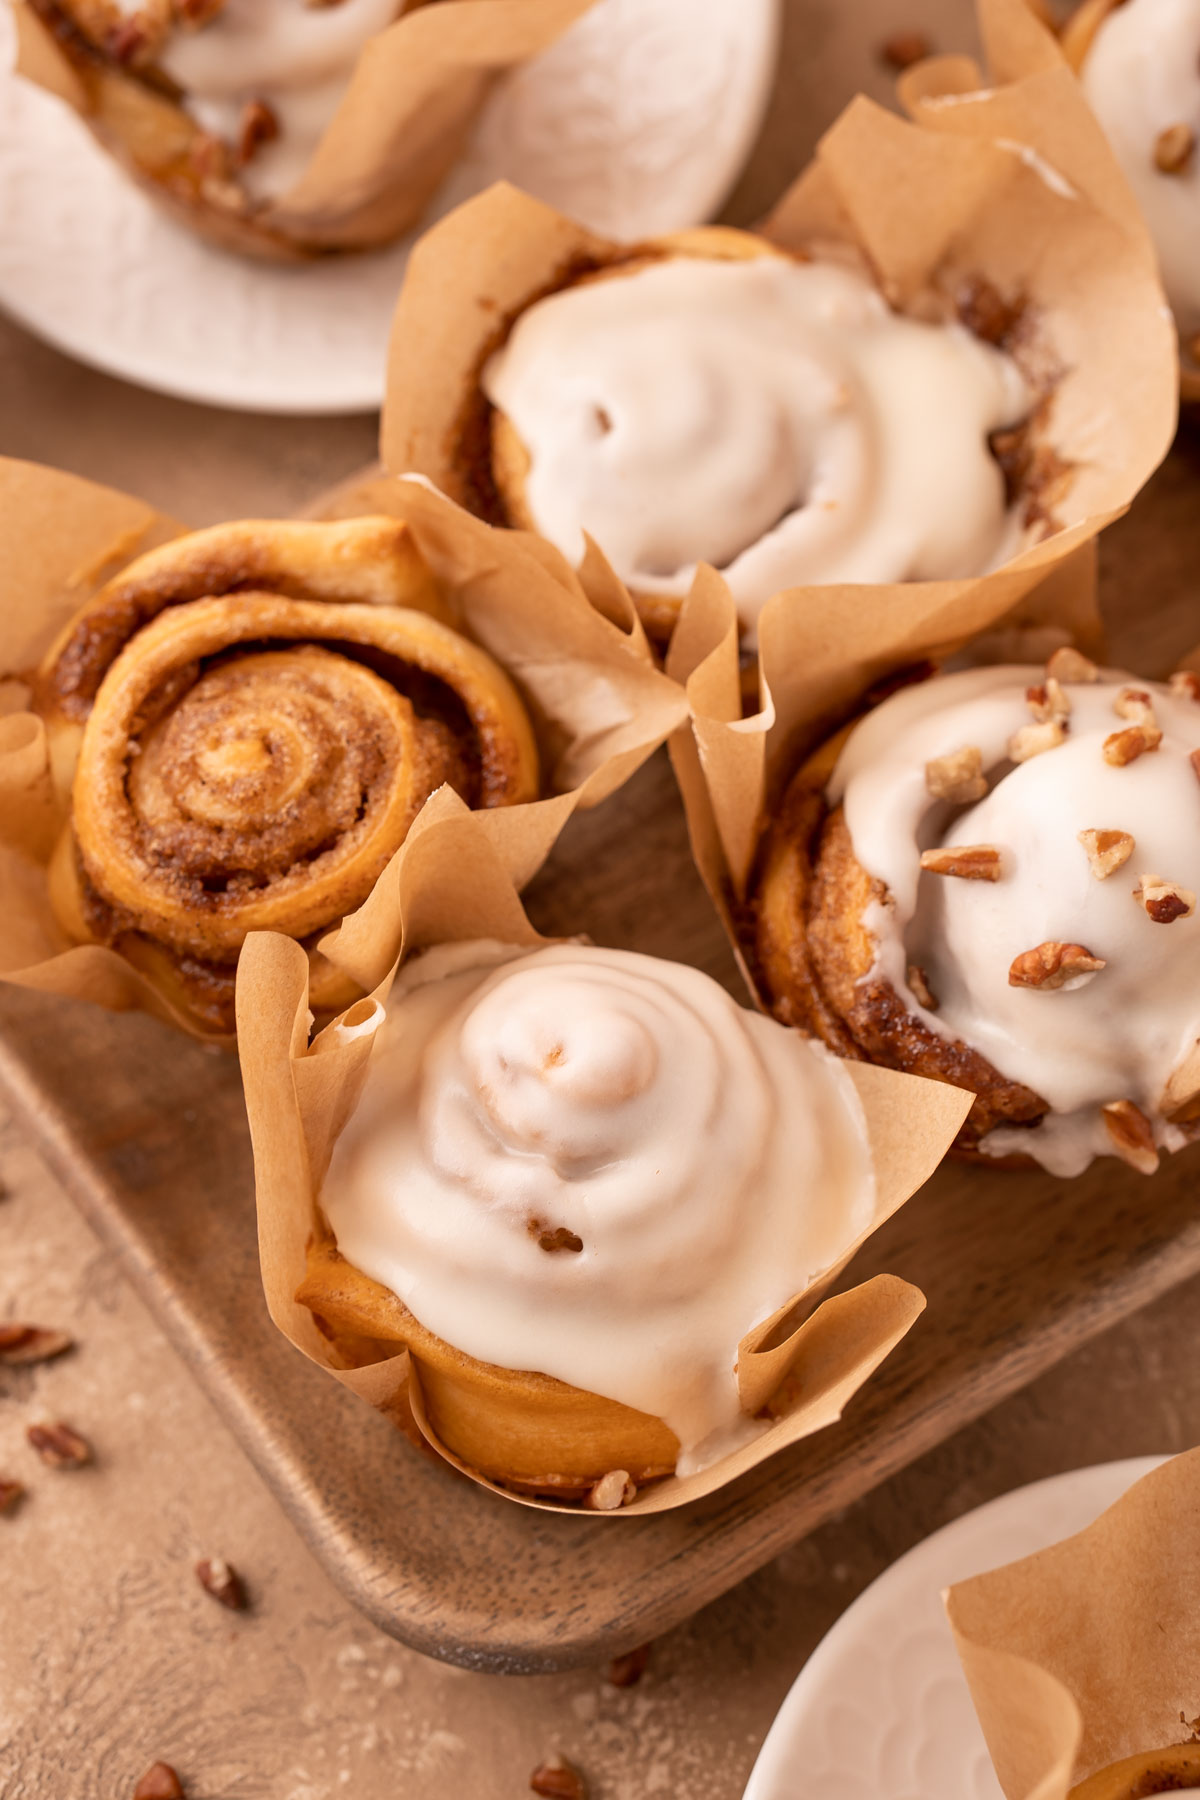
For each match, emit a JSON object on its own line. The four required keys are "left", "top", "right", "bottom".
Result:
{"left": 0, "top": 459, "right": 687, "bottom": 1042}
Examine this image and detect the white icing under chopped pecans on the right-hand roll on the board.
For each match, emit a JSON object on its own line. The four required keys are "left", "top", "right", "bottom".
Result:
{"left": 829, "top": 666, "right": 1200, "bottom": 1175}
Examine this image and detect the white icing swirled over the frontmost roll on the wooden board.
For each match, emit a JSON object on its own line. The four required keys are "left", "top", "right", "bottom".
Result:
{"left": 322, "top": 943, "right": 876, "bottom": 1474}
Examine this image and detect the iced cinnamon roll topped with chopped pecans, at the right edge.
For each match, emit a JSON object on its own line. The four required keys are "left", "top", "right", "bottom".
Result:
{"left": 750, "top": 650, "right": 1200, "bottom": 1175}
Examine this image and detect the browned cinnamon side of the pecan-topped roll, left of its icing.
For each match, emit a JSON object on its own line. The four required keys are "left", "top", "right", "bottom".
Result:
{"left": 752, "top": 734, "right": 1049, "bottom": 1168}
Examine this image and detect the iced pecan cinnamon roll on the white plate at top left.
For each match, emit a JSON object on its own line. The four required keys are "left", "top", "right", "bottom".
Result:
{"left": 29, "top": 0, "right": 415, "bottom": 256}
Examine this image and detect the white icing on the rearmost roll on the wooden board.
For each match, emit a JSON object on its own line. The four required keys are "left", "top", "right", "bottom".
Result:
{"left": 484, "top": 256, "right": 1031, "bottom": 626}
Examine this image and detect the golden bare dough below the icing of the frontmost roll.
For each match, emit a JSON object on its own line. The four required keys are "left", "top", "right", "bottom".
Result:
{"left": 295, "top": 1238, "right": 678, "bottom": 1499}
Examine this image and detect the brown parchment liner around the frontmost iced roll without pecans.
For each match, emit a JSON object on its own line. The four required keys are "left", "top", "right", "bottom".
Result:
{"left": 237, "top": 788, "right": 970, "bottom": 1516}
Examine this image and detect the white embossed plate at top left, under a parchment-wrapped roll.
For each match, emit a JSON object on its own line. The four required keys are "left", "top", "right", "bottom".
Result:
{"left": 0, "top": 0, "right": 779, "bottom": 412}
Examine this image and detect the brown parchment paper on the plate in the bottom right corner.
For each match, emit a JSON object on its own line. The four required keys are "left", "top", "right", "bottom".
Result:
{"left": 945, "top": 1451, "right": 1200, "bottom": 1800}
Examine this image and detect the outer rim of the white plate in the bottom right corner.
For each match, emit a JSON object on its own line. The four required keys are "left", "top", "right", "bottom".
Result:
{"left": 743, "top": 1456, "right": 1169, "bottom": 1800}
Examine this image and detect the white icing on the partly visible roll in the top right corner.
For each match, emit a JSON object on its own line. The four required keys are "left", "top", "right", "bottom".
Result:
{"left": 1079, "top": 0, "right": 1200, "bottom": 333}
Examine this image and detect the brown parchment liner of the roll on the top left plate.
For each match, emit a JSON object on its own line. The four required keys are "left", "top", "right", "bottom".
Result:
{"left": 13, "top": 0, "right": 596, "bottom": 257}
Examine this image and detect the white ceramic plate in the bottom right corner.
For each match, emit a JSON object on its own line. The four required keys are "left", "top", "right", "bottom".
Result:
{"left": 745, "top": 1456, "right": 1162, "bottom": 1800}
